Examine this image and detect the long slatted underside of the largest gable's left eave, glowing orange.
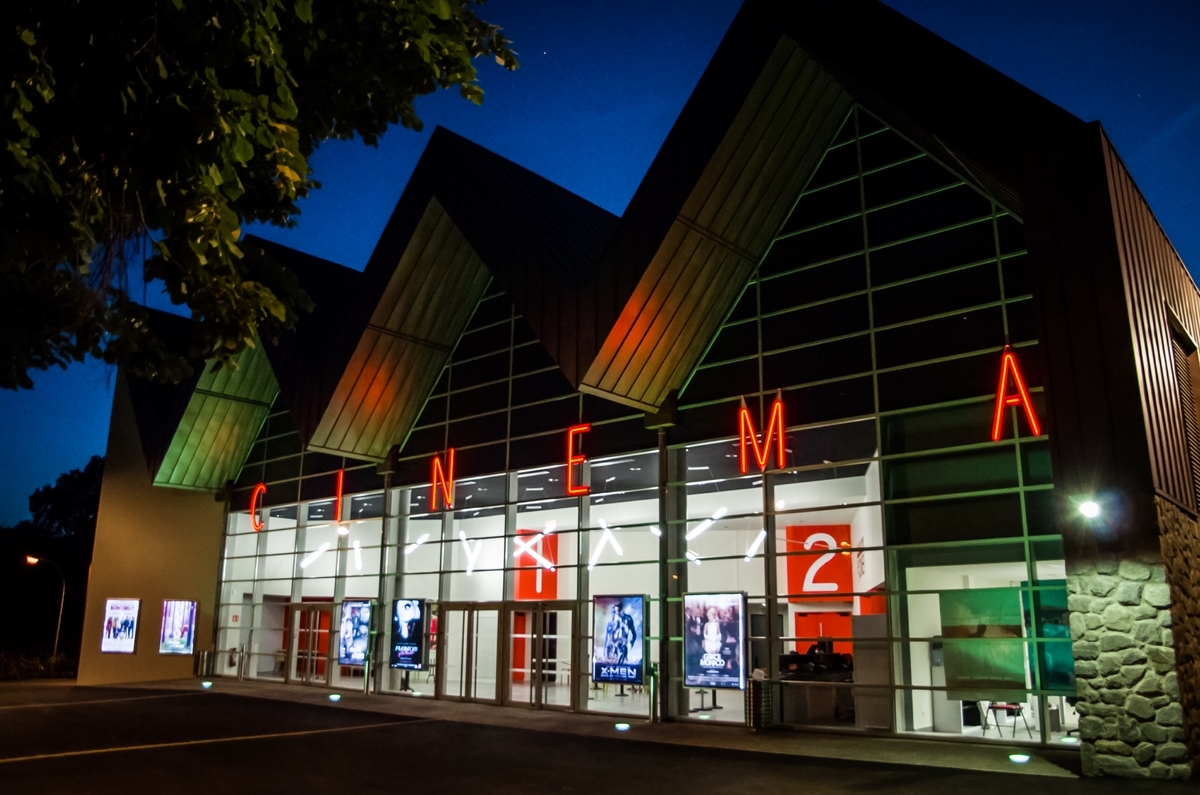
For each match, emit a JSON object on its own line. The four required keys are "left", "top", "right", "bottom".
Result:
{"left": 580, "top": 40, "right": 853, "bottom": 411}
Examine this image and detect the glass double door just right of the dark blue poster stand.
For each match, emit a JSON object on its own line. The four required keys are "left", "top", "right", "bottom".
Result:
{"left": 437, "top": 603, "right": 500, "bottom": 701}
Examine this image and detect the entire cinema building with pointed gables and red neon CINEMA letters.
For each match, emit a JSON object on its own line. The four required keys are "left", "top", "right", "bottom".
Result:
{"left": 79, "top": 1, "right": 1200, "bottom": 778}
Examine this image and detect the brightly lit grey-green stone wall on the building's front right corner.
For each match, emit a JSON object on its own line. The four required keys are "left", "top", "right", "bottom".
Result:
{"left": 1067, "top": 547, "right": 1190, "bottom": 778}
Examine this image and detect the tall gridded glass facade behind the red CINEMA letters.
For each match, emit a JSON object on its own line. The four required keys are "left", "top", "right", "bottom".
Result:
{"left": 218, "top": 108, "right": 1078, "bottom": 741}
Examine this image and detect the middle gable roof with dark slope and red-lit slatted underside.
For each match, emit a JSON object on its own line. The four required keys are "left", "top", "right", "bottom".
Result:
{"left": 305, "top": 128, "right": 616, "bottom": 460}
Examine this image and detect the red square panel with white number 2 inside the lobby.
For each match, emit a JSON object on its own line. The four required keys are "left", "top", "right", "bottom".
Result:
{"left": 785, "top": 525, "right": 854, "bottom": 602}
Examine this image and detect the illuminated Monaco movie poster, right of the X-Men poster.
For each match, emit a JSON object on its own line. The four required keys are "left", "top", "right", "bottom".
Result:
{"left": 683, "top": 593, "right": 746, "bottom": 691}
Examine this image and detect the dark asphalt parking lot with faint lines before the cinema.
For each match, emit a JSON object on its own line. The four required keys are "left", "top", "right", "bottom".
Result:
{"left": 0, "top": 686, "right": 1200, "bottom": 795}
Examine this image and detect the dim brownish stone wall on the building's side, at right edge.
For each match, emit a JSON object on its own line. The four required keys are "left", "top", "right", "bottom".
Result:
{"left": 1154, "top": 497, "right": 1200, "bottom": 767}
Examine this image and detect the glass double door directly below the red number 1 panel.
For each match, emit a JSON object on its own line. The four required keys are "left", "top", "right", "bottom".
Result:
{"left": 504, "top": 602, "right": 575, "bottom": 710}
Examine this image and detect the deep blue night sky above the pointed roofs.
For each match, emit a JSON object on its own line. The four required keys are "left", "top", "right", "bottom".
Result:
{"left": 0, "top": 0, "right": 1200, "bottom": 524}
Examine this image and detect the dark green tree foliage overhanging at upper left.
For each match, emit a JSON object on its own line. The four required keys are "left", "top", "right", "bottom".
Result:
{"left": 0, "top": 0, "right": 517, "bottom": 388}
